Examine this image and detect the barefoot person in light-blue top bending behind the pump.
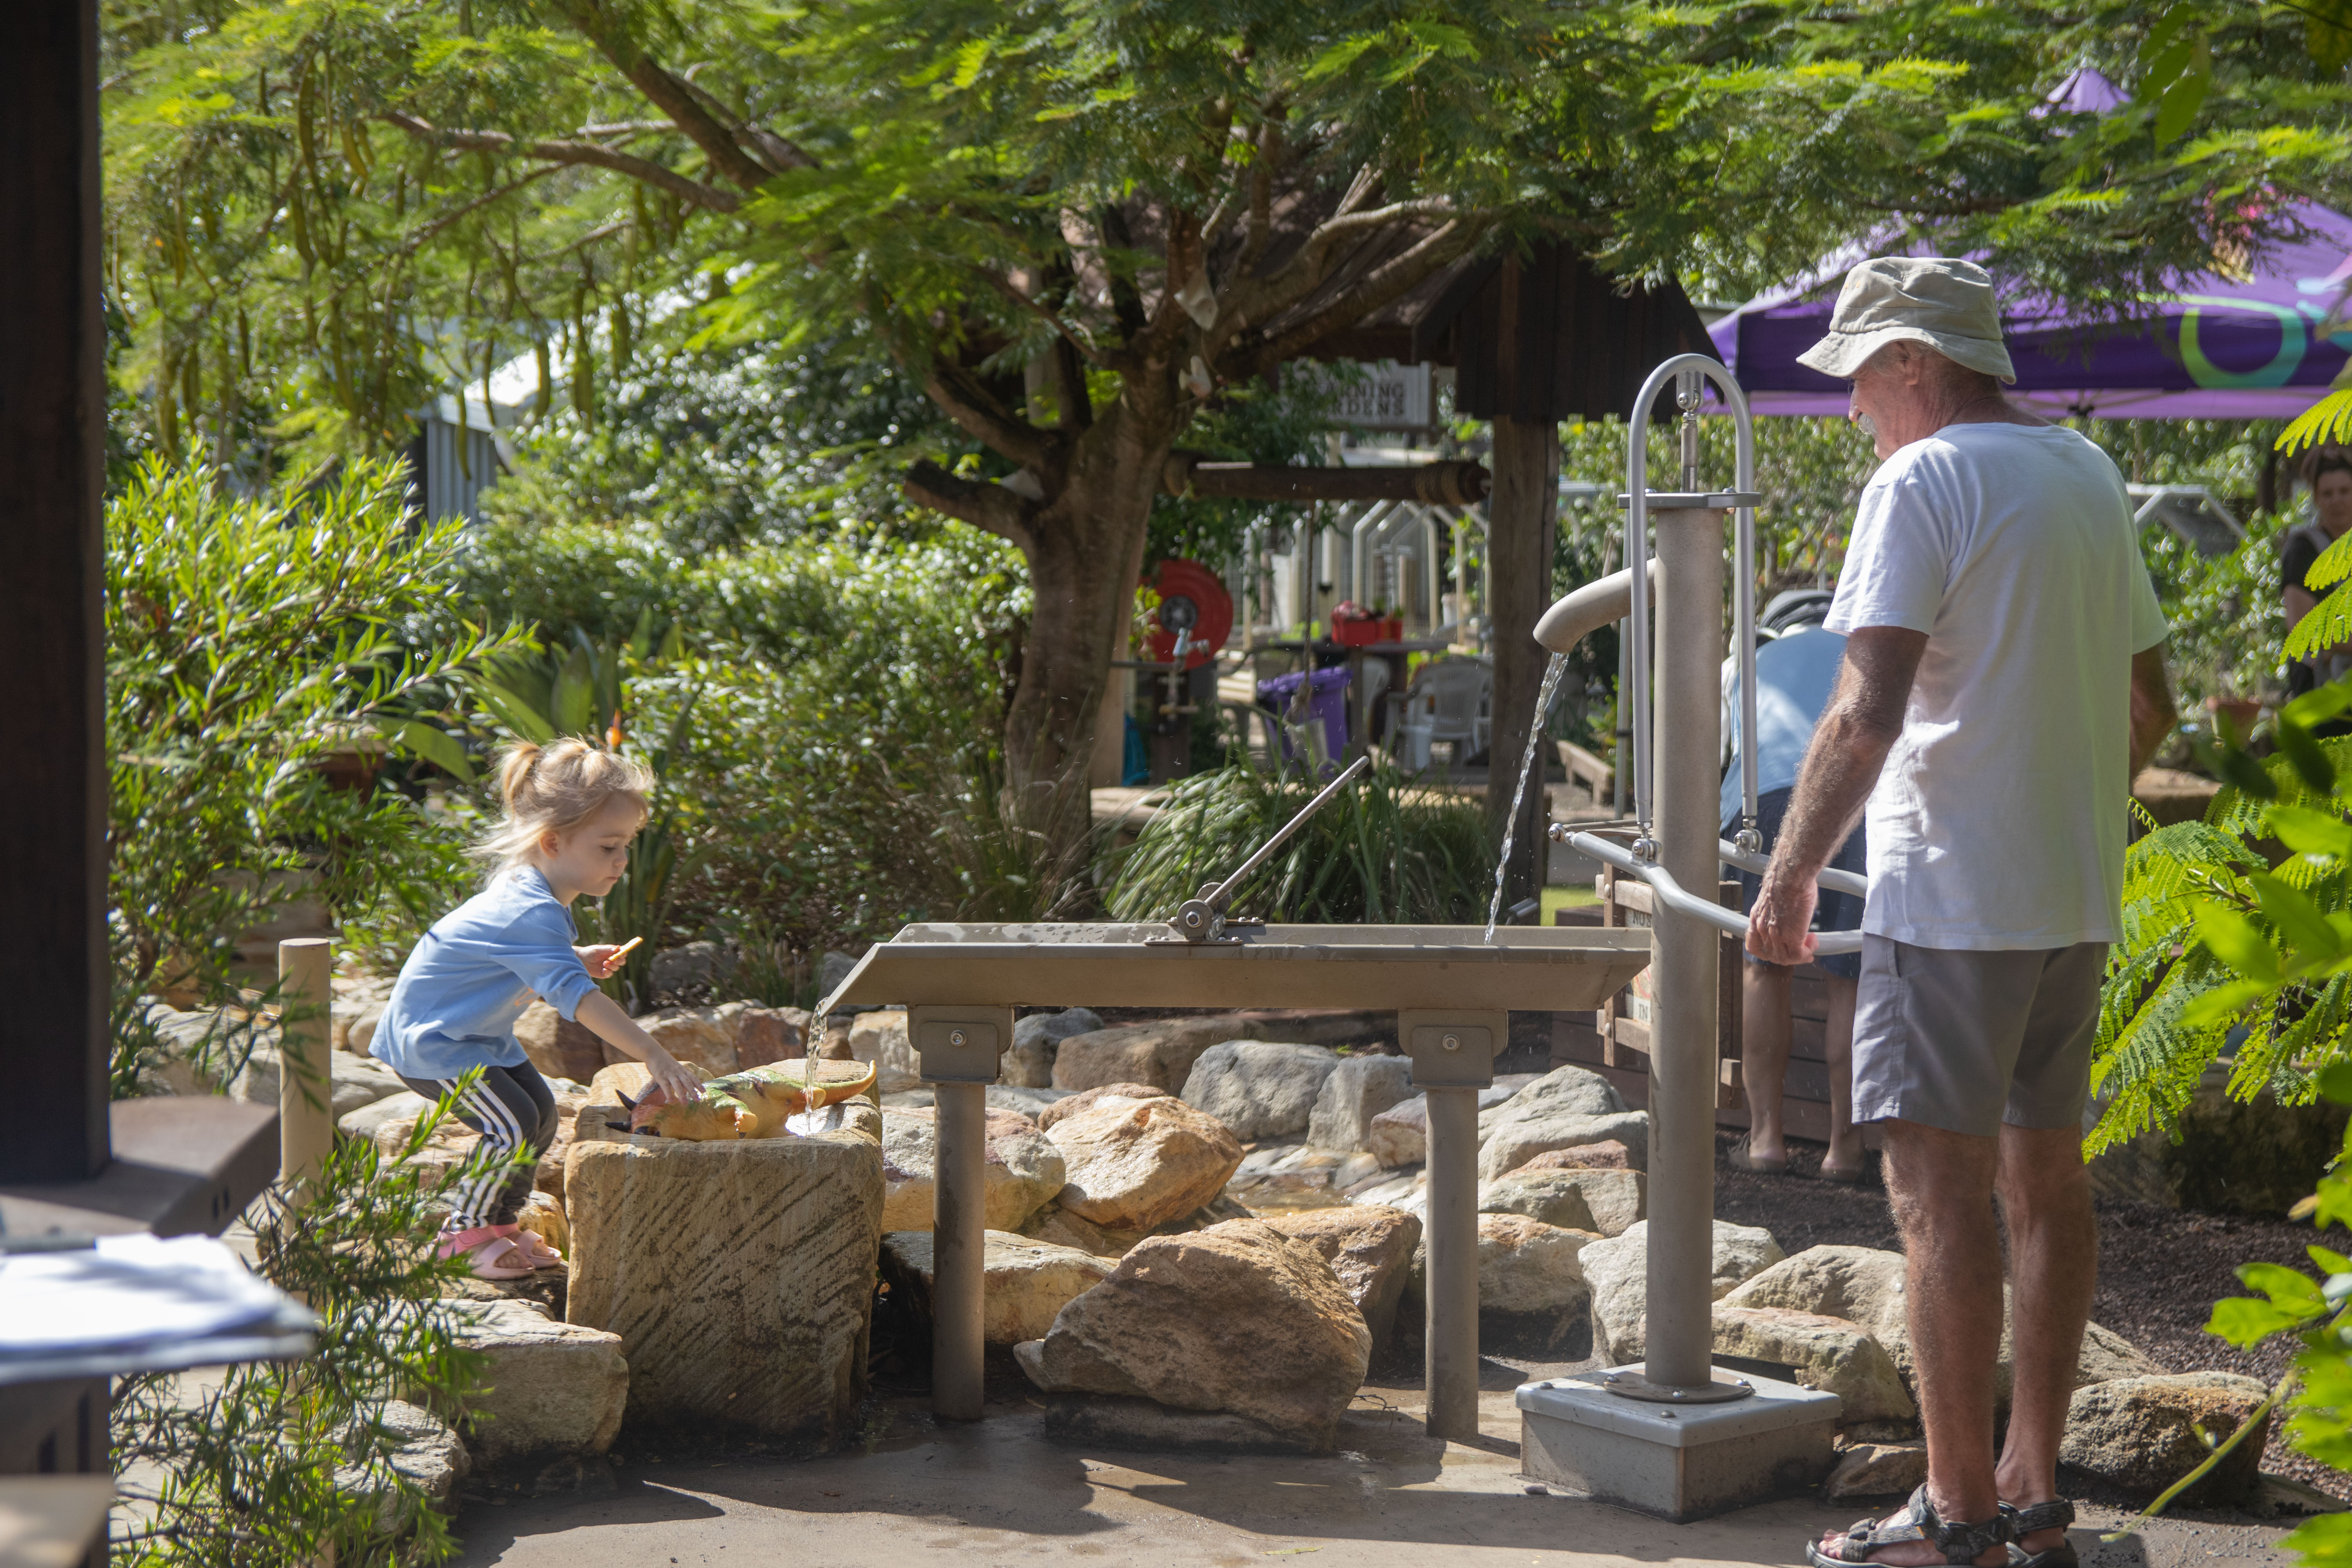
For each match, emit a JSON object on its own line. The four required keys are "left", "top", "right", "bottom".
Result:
{"left": 1722, "top": 588, "right": 1863, "bottom": 1182}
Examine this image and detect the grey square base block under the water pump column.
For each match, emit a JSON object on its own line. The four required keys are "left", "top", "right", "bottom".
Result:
{"left": 1517, "top": 1366, "right": 1844, "bottom": 1523}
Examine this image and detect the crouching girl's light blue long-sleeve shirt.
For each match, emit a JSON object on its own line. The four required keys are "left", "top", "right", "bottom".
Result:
{"left": 369, "top": 865, "right": 595, "bottom": 1079}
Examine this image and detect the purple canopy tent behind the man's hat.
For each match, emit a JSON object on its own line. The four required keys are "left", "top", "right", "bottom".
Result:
{"left": 1708, "top": 71, "right": 2352, "bottom": 418}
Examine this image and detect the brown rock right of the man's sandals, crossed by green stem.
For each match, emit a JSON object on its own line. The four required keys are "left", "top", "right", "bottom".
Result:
{"left": 2058, "top": 1373, "right": 2270, "bottom": 1507}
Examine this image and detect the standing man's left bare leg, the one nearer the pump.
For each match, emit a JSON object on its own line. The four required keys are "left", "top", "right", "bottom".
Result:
{"left": 1823, "top": 1122, "right": 2009, "bottom": 1568}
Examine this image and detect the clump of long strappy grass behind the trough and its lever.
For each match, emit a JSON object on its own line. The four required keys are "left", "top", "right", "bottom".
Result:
{"left": 1103, "top": 762, "right": 1494, "bottom": 924}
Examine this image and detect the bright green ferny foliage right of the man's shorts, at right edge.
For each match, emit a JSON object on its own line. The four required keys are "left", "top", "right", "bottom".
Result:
{"left": 2084, "top": 682, "right": 2352, "bottom": 1154}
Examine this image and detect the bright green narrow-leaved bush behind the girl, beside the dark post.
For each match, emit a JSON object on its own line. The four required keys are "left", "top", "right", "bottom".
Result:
{"left": 106, "top": 458, "right": 520, "bottom": 1020}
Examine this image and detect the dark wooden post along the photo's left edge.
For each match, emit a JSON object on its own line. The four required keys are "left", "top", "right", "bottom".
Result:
{"left": 0, "top": 0, "right": 111, "bottom": 1185}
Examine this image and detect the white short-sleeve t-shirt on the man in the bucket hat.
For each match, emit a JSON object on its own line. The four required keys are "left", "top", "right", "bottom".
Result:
{"left": 1828, "top": 423, "right": 2164, "bottom": 950}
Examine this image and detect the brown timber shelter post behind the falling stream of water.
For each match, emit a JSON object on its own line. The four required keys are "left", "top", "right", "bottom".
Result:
{"left": 1486, "top": 418, "right": 1559, "bottom": 907}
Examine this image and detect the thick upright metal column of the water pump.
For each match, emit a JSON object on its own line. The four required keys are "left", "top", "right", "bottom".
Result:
{"left": 1632, "top": 510, "right": 1724, "bottom": 1387}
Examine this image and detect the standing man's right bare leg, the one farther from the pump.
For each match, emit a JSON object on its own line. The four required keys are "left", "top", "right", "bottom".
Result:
{"left": 1994, "top": 1126, "right": 2098, "bottom": 1552}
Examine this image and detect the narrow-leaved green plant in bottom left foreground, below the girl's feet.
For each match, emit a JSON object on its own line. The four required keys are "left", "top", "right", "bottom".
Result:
{"left": 111, "top": 1110, "right": 501, "bottom": 1568}
